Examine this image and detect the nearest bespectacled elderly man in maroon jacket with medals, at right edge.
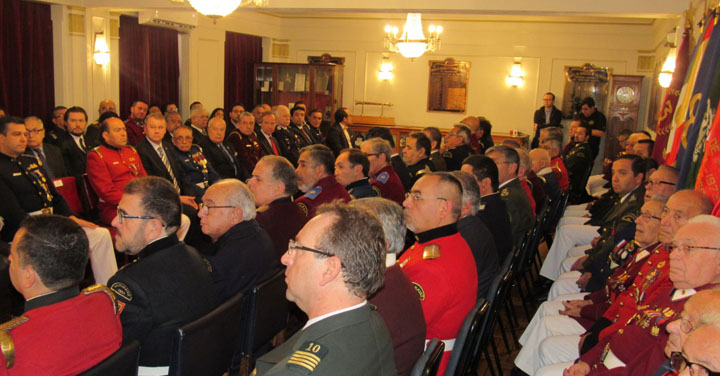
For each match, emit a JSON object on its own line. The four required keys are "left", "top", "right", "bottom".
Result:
{"left": 556, "top": 215, "right": 720, "bottom": 375}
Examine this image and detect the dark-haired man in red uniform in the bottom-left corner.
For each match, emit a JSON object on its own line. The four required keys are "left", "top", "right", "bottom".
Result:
{"left": 0, "top": 215, "right": 122, "bottom": 376}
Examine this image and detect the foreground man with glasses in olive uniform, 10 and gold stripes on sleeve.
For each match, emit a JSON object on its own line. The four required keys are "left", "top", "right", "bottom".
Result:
{"left": 253, "top": 203, "right": 397, "bottom": 376}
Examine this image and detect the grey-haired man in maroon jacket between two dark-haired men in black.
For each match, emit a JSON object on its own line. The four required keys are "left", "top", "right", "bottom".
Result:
{"left": 360, "top": 137, "right": 405, "bottom": 205}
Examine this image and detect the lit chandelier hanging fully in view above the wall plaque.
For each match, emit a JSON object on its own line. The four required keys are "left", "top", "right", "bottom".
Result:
{"left": 386, "top": 13, "right": 443, "bottom": 59}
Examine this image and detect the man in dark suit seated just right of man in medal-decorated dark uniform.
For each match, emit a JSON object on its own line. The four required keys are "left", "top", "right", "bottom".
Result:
{"left": 200, "top": 117, "right": 250, "bottom": 181}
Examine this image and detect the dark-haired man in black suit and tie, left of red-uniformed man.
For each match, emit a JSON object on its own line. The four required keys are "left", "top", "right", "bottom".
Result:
{"left": 60, "top": 107, "right": 100, "bottom": 178}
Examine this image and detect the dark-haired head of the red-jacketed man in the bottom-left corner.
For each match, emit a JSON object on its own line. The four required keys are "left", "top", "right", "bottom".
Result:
{"left": 16, "top": 215, "right": 89, "bottom": 290}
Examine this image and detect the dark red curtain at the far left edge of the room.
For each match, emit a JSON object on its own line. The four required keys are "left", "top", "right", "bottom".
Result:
{"left": 0, "top": 0, "right": 55, "bottom": 118}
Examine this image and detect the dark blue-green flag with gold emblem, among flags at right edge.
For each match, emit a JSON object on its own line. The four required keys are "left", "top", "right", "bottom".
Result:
{"left": 676, "top": 15, "right": 720, "bottom": 188}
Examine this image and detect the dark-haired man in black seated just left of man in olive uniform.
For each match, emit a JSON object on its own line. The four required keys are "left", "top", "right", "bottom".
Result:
{"left": 460, "top": 154, "right": 513, "bottom": 260}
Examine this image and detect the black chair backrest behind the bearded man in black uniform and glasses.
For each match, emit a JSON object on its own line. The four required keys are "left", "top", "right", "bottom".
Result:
{"left": 170, "top": 293, "right": 245, "bottom": 376}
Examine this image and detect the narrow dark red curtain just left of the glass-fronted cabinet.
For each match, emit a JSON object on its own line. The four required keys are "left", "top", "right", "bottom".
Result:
{"left": 225, "top": 31, "right": 262, "bottom": 111}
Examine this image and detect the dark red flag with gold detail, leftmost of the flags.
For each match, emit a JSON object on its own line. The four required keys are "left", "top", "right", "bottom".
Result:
{"left": 652, "top": 27, "right": 692, "bottom": 164}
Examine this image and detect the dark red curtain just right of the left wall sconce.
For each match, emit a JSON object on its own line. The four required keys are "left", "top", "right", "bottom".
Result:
{"left": 118, "top": 16, "right": 180, "bottom": 119}
